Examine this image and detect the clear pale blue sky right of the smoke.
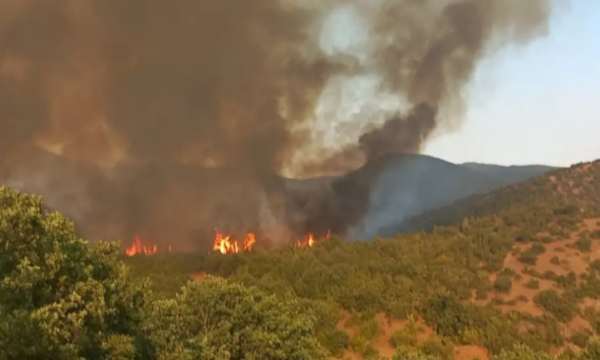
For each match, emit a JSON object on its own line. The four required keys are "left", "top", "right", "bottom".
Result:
{"left": 425, "top": 0, "right": 600, "bottom": 166}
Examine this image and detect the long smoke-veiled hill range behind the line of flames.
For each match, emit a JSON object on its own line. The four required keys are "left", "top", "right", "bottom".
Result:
{"left": 0, "top": 148, "right": 549, "bottom": 245}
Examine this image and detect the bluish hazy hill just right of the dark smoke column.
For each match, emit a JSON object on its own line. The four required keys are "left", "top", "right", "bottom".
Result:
{"left": 346, "top": 154, "right": 553, "bottom": 240}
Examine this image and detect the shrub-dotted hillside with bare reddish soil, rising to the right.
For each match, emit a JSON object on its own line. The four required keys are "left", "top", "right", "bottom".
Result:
{"left": 122, "top": 161, "right": 600, "bottom": 360}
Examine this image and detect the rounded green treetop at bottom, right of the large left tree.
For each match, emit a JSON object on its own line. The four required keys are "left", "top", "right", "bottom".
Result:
{"left": 144, "top": 276, "right": 327, "bottom": 360}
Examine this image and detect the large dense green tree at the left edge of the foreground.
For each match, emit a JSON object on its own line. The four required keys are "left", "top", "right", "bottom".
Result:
{"left": 0, "top": 186, "right": 146, "bottom": 360}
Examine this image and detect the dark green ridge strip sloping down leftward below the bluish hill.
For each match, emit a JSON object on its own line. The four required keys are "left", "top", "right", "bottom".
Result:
{"left": 394, "top": 160, "right": 600, "bottom": 231}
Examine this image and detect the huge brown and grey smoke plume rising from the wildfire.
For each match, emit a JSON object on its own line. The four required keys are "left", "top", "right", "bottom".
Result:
{"left": 0, "top": 0, "right": 552, "bottom": 246}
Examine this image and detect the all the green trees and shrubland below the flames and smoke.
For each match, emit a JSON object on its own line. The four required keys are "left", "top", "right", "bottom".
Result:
{"left": 0, "top": 161, "right": 600, "bottom": 360}
